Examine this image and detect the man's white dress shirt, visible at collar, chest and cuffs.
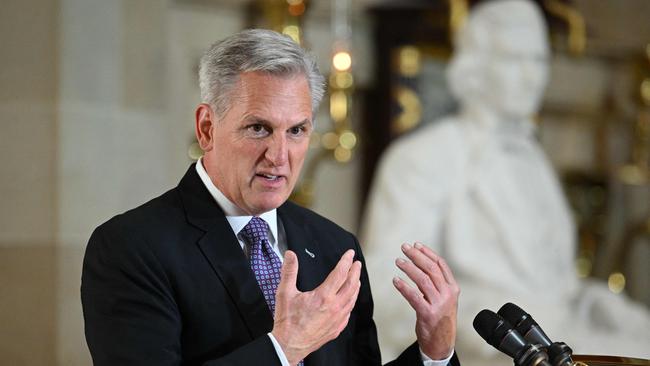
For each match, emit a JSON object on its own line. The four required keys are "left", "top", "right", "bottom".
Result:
{"left": 196, "top": 158, "right": 453, "bottom": 366}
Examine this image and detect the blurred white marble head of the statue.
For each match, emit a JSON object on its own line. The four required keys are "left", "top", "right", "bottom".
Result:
{"left": 447, "top": 0, "right": 549, "bottom": 120}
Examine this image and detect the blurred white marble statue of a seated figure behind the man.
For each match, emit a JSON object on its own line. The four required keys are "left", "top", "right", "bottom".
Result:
{"left": 361, "top": 0, "right": 650, "bottom": 365}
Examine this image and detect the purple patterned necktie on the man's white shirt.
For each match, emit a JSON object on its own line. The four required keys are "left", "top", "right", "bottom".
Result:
{"left": 240, "top": 217, "right": 282, "bottom": 315}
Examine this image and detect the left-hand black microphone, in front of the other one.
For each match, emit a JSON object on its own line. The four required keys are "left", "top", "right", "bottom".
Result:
{"left": 473, "top": 309, "right": 551, "bottom": 366}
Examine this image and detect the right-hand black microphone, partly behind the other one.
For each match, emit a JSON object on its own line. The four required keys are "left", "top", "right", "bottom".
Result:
{"left": 497, "top": 302, "right": 573, "bottom": 366}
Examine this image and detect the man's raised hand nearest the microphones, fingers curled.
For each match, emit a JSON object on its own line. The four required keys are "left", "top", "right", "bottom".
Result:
{"left": 393, "top": 243, "right": 460, "bottom": 360}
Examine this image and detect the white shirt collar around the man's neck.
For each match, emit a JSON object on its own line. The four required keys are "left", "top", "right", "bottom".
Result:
{"left": 196, "top": 158, "right": 278, "bottom": 245}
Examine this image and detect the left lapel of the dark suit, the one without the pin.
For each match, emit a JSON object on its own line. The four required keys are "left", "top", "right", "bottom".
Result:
{"left": 178, "top": 164, "right": 273, "bottom": 339}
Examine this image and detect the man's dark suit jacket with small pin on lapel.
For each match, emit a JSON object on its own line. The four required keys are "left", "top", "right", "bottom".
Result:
{"left": 81, "top": 165, "right": 458, "bottom": 366}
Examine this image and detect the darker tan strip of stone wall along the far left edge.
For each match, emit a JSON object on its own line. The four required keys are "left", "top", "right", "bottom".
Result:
{"left": 0, "top": 0, "right": 59, "bottom": 365}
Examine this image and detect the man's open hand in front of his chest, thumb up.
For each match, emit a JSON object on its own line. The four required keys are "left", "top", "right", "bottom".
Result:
{"left": 271, "top": 250, "right": 361, "bottom": 365}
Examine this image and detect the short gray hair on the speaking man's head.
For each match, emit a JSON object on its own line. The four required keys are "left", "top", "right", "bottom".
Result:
{"left": 199, "top": 29, "right": 325, "bottom": 117}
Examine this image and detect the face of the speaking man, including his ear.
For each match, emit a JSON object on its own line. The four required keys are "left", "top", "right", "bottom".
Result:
{"left": 196, "top": 72, "right": 313, "bottom": 215}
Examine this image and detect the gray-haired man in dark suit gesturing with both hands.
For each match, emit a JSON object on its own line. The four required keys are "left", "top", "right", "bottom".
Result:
{"left": 81, "top": 30, "right": 459, "bottom": 365}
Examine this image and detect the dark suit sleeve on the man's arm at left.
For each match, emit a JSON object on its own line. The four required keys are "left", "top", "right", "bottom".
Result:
{"left": 81, "top": 226, "right": 280, "bottom": 366}
